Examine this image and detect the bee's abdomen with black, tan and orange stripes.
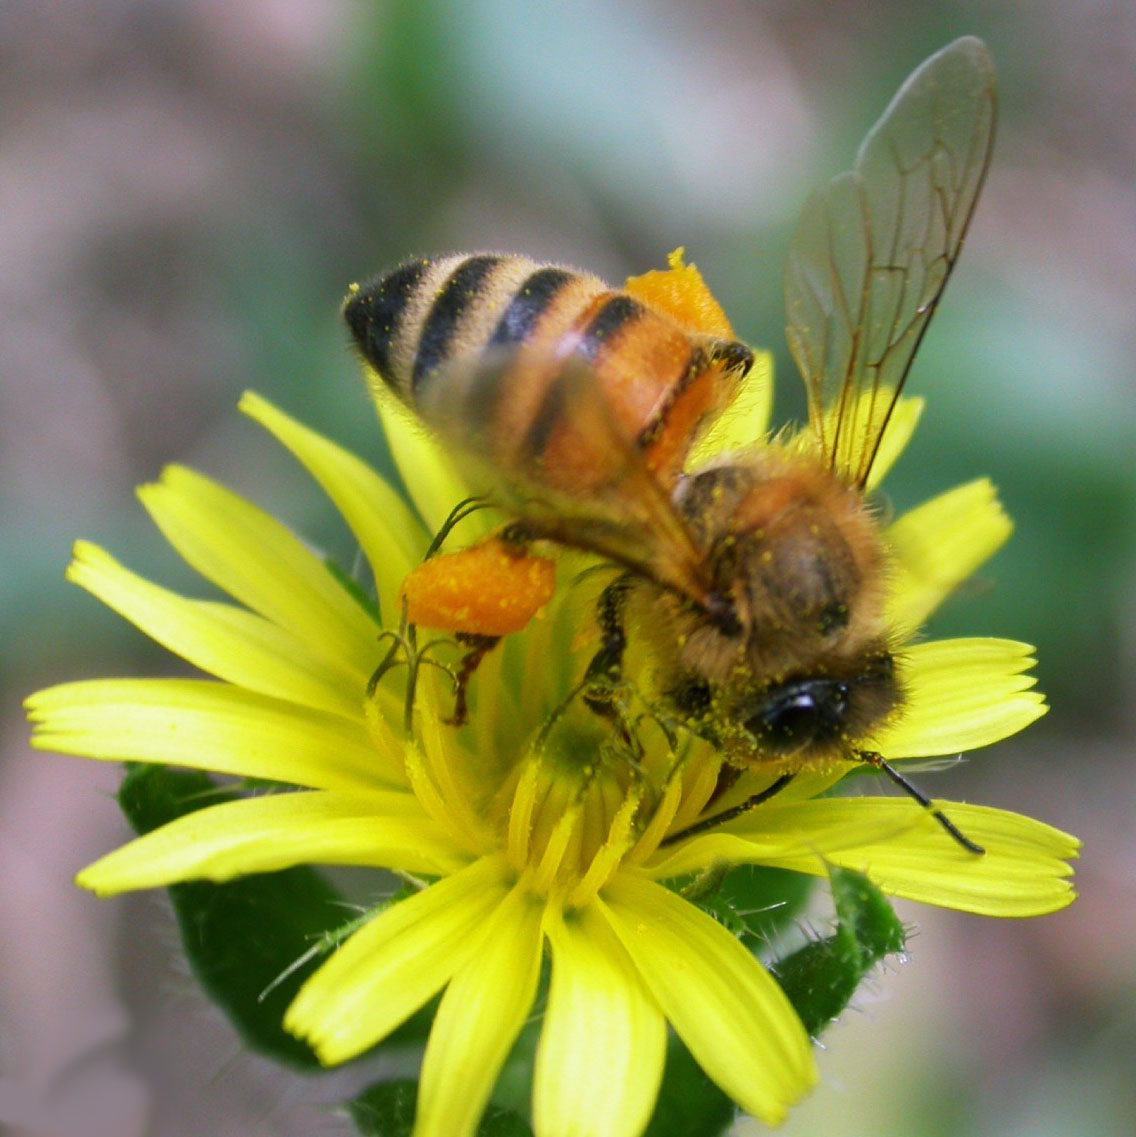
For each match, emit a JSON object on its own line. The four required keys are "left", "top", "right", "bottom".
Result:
{"left": 343, "top": 252, "right": 753, "bottom": 496}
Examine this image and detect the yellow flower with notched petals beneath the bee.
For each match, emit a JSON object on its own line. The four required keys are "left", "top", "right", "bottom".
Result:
{"left": 28, "top": 384, "right": 1077, "bottom": 1137}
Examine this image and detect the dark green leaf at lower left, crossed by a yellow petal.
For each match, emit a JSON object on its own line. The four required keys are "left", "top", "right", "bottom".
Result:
{"left": 118, "top": 765, "right": 345, "bottom": 1069}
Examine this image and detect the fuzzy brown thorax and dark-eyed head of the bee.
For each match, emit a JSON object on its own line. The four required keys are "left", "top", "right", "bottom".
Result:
{"left": 653, "top": 447, "right": 902, "bottom": 769}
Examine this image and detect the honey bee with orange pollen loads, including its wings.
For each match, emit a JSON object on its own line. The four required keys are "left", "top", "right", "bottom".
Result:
{"left": 343, "top": 38, "right": 995, "bottom": 853}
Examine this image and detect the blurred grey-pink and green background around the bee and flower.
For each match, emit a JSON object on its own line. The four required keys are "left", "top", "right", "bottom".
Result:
{"left": 0, "top": 0, "right": 1136, "bottom": 1137}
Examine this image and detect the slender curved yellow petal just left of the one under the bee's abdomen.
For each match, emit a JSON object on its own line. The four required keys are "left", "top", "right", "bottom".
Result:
{"left": 240, "top": 391, "right": 430, "bottom": 621}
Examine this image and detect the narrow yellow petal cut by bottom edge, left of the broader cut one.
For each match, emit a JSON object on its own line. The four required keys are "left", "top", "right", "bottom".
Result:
{"left": 414, "top": 888, "right": 542, "bottom": 1137}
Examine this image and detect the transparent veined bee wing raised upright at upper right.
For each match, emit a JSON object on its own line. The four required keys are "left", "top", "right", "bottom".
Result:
{"left": 785, "top": 36, "right": 995, "bottom": 487}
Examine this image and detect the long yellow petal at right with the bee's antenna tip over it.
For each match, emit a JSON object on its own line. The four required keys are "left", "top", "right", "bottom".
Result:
{"left": 735, "top": 797, "right": 1080, "bottom": 916}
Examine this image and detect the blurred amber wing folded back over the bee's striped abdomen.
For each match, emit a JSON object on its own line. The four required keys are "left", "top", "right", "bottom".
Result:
{"left": 416, "top": 348, "right": 713, "bottom": 607}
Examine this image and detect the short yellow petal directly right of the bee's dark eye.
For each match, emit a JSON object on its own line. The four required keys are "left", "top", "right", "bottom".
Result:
{"left": 877, "top": 638, "right": 1046, "bottom": 758}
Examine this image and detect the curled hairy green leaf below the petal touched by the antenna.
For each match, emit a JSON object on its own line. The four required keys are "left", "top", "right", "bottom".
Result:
{"left": 770, "top": 869, "right": 905, "bottom": 1038}
